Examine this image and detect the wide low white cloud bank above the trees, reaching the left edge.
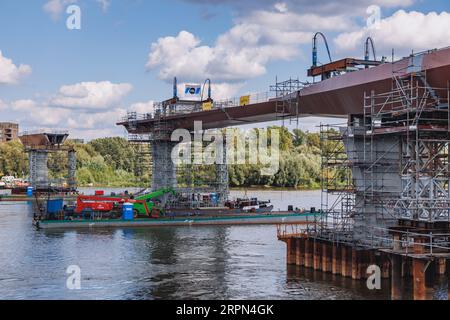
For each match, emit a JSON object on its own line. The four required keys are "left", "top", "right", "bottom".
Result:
{"left": 0, "top": 81, "right": 131, "bottom": 138}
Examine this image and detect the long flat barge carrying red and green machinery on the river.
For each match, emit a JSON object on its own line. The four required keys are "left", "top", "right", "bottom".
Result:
{"left": 29, "top": 188, "right": 321, "bottom": 229}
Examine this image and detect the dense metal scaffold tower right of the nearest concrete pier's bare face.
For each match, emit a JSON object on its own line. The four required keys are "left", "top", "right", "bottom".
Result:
{"left": 364, "top": 72, "right": 450, "bottom": 223}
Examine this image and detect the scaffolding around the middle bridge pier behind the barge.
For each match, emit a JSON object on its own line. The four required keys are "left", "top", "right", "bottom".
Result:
{"left": 126, "top": 99, "right": 229, "bottom": 209}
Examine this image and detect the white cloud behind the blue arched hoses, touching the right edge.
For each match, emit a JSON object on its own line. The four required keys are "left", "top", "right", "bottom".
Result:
{"left": 334, "top": 10, "right": 450, "bottom": 55}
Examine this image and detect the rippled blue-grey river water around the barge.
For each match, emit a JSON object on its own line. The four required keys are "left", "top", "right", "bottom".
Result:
{"left": 0, "top": 189, "right": 389, "bottom": 300}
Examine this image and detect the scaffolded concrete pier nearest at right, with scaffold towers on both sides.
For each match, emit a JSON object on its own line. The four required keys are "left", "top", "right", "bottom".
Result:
{"left": 312, "top": 73, "right": 450, "bottom": 248}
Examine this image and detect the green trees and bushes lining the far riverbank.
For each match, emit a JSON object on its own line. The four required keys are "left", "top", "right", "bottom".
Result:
{"left": 0, "top": 127, "right": 340, "bottom": 191}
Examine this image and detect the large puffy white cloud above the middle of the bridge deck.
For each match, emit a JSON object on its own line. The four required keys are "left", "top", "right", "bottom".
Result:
{"left": 147, "top": 3, "right": 355, "bottom": 83}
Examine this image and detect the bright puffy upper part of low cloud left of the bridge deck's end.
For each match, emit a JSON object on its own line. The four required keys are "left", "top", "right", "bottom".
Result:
{"left": 50, "top": 81, "right": 133, "bottom": 110}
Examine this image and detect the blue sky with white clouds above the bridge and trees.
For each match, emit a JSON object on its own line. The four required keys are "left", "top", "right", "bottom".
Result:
{"left": 0, "top": 0, "right": 450, "bottom": 140}
